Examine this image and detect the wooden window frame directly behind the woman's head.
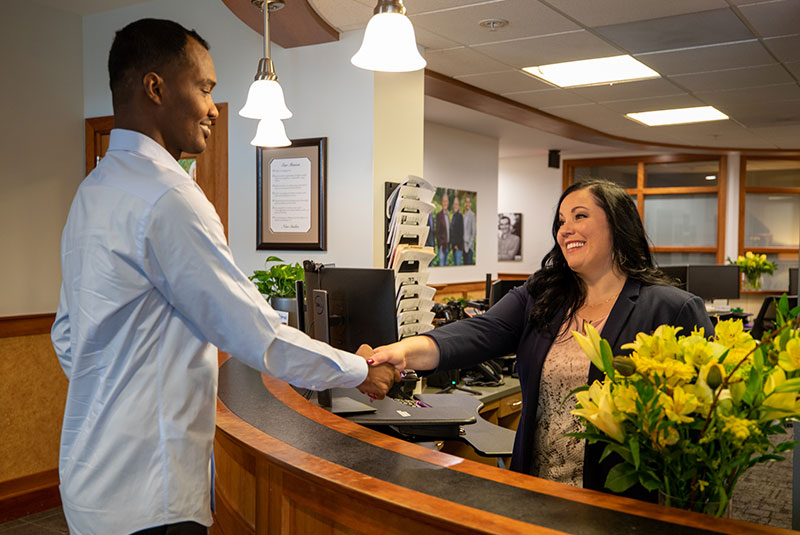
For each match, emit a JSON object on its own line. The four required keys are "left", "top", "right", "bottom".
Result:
{"left": 561, "top": 154, "right": 728, "bottom": 264}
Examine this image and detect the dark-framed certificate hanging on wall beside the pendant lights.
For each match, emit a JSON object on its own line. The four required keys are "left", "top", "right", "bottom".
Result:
{"left": 256, "top": 137, "right": 328, "bottom": 251}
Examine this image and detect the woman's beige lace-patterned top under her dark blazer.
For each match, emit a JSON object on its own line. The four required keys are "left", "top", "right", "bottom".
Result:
{"left": 532, "top": 315, "right": 608, "bottom": 487}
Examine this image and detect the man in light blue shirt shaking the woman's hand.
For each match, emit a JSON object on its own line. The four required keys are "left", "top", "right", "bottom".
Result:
{"left": 52, "top": 19, "right": 396, "bottom": 535}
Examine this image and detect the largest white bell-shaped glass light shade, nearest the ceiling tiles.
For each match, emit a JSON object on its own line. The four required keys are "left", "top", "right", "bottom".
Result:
{"left": 350, "top": 13, "right": 426, "bottom": 72}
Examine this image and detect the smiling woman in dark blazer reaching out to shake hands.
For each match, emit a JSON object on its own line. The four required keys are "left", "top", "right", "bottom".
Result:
{"left": 373, "top": 180, "right": 713, "bottom": 499}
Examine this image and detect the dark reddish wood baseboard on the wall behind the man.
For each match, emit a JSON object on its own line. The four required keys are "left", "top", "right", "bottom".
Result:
{"left": 0, "top": 469, "right": 61, "bottom": 522}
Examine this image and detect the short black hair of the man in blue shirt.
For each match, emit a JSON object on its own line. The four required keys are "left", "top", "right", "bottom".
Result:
{"left": 108, "top": 19, "right": 208, "bottom": 101}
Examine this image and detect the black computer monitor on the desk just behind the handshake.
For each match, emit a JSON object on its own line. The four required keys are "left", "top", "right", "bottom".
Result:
{"left": 305, "top": 265, "right": 397, "bottom": 353}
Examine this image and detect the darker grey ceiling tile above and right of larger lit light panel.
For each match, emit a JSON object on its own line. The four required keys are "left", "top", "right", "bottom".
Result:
{"left": 594, "top": 9, "right": 753, "bottom": 54}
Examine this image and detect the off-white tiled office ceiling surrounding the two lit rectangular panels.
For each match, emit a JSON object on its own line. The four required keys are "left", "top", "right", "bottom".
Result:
{"left": 309, "top": 0, "right": 800, "bottom": 155}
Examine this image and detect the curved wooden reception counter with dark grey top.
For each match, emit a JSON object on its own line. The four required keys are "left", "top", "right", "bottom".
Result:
{"left": 211, "top": 359, "right": 792, "bottom": 535}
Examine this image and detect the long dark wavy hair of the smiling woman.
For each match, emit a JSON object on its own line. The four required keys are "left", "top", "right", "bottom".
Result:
{"left": 526, "top": 179, "right": 673, "bottom": 335}
